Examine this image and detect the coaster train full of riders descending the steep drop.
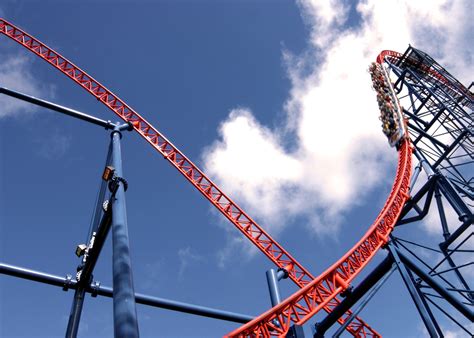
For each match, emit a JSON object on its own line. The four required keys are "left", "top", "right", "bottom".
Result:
{"left": 369, "top": 62, "right": 407, "bottom": 148}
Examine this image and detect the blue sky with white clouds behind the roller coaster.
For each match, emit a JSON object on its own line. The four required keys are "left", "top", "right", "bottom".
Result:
{"left": 0, "top": 1, "right": 472, "bottom": 337}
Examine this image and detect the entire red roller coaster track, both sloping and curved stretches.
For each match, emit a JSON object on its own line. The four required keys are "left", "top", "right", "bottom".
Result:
{"left": 0, "top": 19, "right": 411, "bottom": 337}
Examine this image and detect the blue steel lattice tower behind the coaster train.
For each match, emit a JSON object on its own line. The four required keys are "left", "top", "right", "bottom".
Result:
{"left": 386, "top": 46, "right": 474, "bottom": 337}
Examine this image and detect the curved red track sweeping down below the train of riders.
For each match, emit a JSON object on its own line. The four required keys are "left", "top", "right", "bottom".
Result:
{"left": 226, "top": 51, "right": 412, "bottom": 337}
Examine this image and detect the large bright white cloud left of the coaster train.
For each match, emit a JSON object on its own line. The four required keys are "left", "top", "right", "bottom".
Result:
{"left": 203, "top": 0, "right": 472, "bottom": 244}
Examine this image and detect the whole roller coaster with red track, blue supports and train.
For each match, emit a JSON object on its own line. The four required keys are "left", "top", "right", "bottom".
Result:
{"left": 0, "top": 19, "right": 474, "bottom": 337}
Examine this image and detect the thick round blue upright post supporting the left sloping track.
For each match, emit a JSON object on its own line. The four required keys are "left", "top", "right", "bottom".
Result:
{"left": 111, "top": 126, "right": 138, "bottom": 337}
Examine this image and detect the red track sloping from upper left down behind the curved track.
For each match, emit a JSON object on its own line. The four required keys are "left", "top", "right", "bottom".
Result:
{"left": 0, "top": 18, "right": 379, "bottom": 337}
